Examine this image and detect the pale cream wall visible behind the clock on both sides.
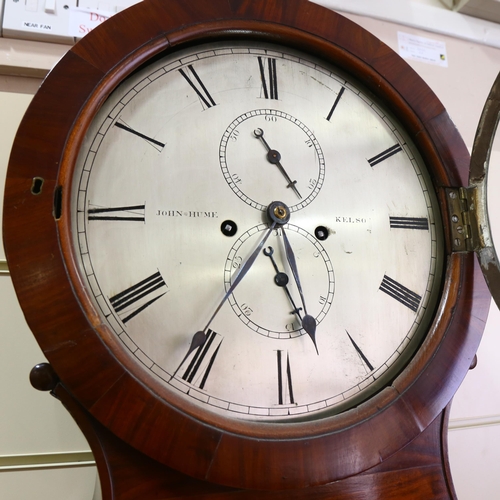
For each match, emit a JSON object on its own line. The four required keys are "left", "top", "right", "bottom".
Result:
{"left": 0, "top": 0, "right": 500, "bottom": 500}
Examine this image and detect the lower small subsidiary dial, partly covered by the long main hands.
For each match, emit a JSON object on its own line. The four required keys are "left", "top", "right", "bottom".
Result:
{"left": 224, "top": 224, "right": 335, "bottom": 339}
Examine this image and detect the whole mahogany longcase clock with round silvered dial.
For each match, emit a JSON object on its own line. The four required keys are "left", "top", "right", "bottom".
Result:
{"left": 4, "top": 0, "right": 496, "bottom": 499}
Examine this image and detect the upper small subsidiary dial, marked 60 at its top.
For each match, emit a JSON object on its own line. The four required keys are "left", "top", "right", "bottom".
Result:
{"left": 219, "top": 109, "right": 325, "bottom": 212}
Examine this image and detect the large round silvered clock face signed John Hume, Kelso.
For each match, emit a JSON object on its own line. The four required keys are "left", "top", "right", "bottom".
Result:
{"left": 71, "top": 43, "right": 441, "bottom": 421}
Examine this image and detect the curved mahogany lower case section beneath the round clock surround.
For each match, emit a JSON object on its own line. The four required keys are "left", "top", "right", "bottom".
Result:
{"left": 46, "top": 372, "right": 456, "bottom": 500}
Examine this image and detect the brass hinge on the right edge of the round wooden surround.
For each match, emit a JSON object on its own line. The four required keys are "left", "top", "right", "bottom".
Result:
{"left": 446, "top": 182, "right": 492, "bottom": 252}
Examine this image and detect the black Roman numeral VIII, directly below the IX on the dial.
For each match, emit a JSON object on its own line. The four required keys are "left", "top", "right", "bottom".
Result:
{"left": 109, "top": 272, "right": 167, "bottom": 323}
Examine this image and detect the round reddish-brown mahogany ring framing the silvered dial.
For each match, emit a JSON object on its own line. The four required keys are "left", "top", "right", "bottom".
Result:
{"left": 3, "top": 0, "right": 490, "bottom": 498}
